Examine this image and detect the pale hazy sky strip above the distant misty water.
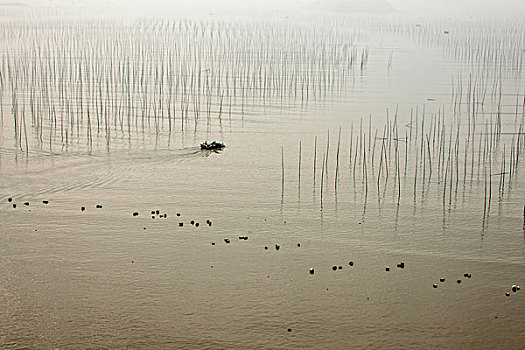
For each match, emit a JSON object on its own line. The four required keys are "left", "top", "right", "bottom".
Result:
{"left": 0, "top": 0, "right": 525, "bottom": 16}
